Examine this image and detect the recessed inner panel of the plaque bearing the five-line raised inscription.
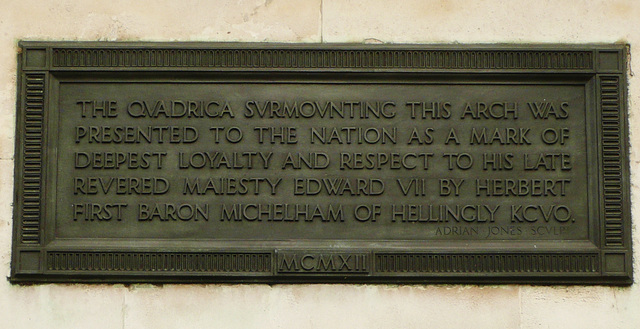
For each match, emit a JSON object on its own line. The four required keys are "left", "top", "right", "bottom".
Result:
{"left": 57, "top": 79, "right": 589, "bottom": 241}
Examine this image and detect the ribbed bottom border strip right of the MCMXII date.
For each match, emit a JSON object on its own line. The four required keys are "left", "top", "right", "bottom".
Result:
{"left": 374, "top": 253, "right": 601, "bottom": 274}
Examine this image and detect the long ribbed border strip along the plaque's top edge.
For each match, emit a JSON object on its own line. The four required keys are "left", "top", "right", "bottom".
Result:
{"left": 52, "top": 47, "right": 594, "bottom": 70}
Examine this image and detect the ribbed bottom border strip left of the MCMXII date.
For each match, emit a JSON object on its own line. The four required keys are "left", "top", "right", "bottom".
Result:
{"left": 46, "top": 251, "right": 271, "bottom": 273}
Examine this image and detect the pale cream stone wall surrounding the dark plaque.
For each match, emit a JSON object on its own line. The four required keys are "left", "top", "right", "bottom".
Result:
{"left": 0, "top": 0, "right": 640, "bottom": 329}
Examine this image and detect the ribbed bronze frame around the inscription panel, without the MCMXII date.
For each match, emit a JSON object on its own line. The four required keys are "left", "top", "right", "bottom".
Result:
{"left": 10, "top": 41, "right": 632, "bottom": 285}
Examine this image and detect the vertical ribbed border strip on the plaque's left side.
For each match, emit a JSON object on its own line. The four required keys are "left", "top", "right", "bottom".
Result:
{"left": 20, "top": 74, "right": 45, "bottom": 244}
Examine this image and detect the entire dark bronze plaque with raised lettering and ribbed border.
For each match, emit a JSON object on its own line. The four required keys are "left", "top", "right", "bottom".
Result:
{"left": 11, "top": 42, "right": 632, "bottom": 284}
